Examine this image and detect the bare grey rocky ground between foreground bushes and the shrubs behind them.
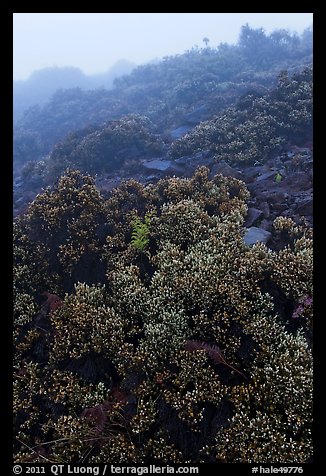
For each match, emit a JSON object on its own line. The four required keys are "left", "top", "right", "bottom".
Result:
{"left": 14, "top": 144, "right": 313, "bottom": 251}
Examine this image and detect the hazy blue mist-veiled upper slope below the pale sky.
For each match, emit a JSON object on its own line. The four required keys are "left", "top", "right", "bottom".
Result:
{"left": 14, "top": 26, "right": 312, "bottom": 172}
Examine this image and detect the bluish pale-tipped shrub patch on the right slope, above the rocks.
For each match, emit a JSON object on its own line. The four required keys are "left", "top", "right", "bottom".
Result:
{"left": 170, "top": 68, "right": 312, "bottom": 163}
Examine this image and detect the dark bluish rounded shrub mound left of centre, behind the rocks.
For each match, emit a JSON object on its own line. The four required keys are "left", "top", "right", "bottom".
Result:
{"left": 22, "top": 115, "right": 163, "bottom": 185}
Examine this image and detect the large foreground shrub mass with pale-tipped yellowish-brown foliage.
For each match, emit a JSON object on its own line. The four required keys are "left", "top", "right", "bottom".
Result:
{"left": 14, "top": 168, "right": 312, "bottom": 464}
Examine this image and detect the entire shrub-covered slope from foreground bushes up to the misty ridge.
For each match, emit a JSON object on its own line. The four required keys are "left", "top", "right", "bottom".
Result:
{"left": 13, "top": 26, "right": 313, "bottom": 465}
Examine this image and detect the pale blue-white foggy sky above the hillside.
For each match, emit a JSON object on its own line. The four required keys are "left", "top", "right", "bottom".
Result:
{"left": 13, "top": 13, "right": 313, "bottom": 80}
